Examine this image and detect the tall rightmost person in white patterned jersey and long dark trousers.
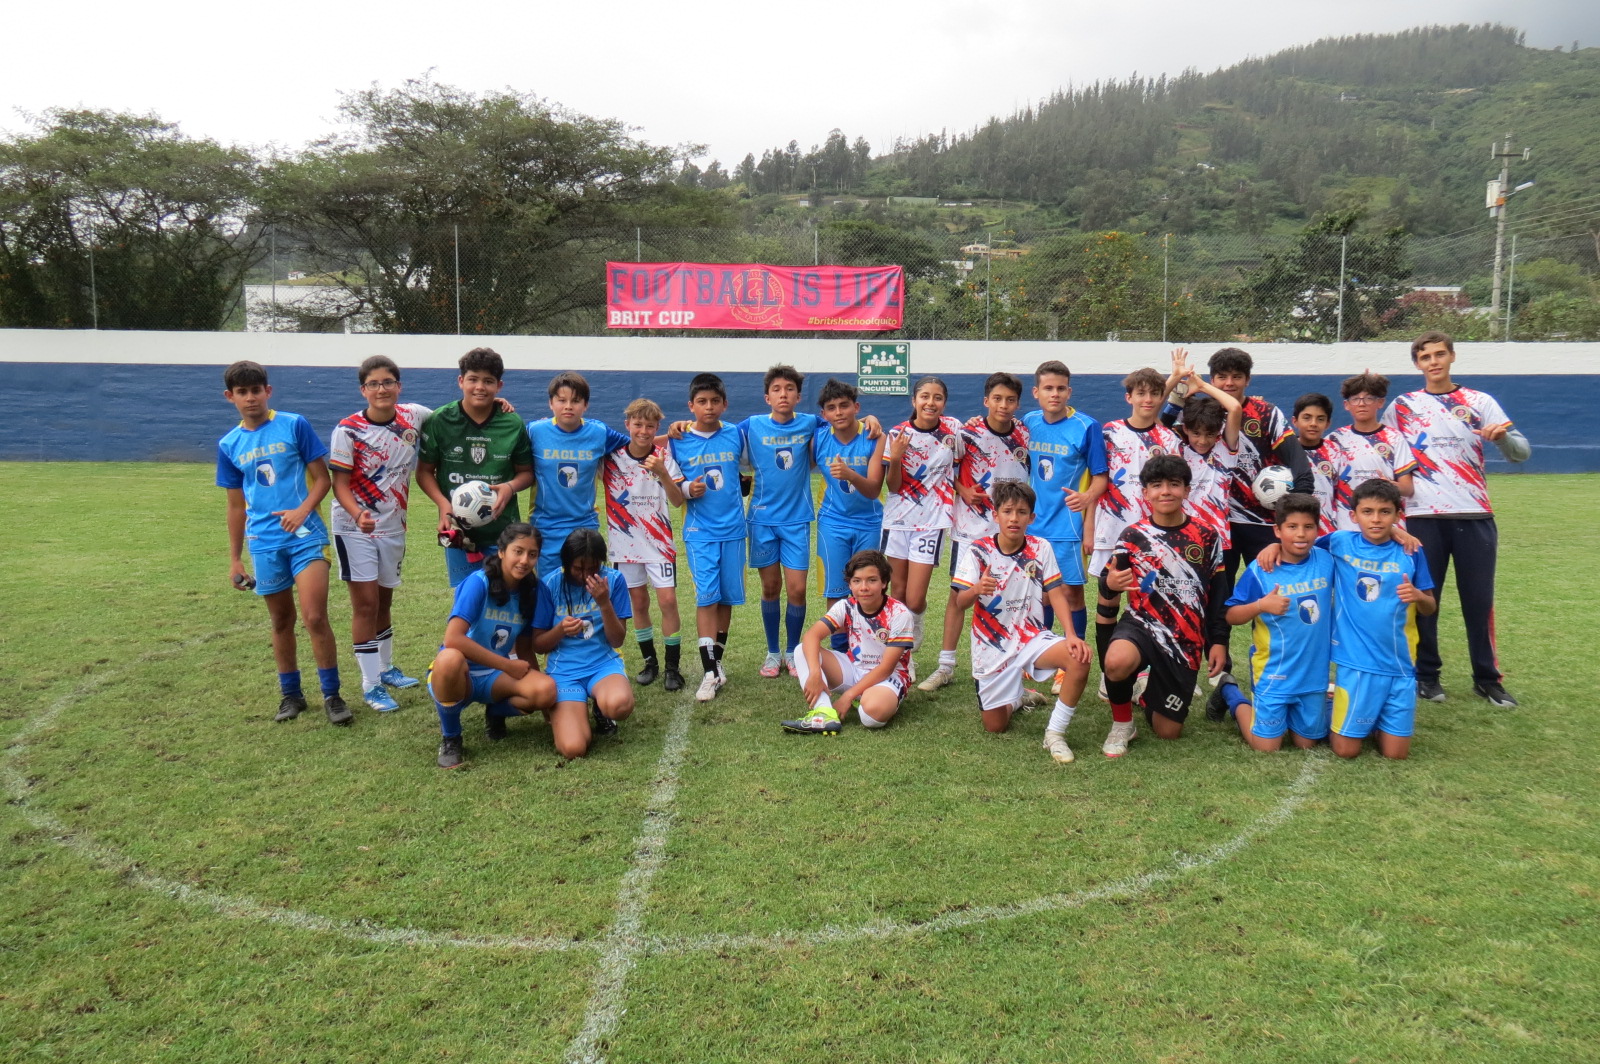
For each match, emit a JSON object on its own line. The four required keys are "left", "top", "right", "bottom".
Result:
{"left": 1384, "top": 333, "right": 1533, "bottom": 709}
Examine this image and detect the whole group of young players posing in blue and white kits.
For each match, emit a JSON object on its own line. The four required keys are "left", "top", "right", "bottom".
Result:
{"left": 218, "top": 333, "right": 1528, "bottom": 768}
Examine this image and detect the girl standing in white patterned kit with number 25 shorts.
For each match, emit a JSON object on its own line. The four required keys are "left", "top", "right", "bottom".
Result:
{"left": 883, "top": 376, "right": 962, "bottom": 669}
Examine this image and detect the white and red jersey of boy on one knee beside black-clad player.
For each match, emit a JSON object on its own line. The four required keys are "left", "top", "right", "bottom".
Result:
{"left": 950, "top": 536, "right": 1061, "bottom": 677}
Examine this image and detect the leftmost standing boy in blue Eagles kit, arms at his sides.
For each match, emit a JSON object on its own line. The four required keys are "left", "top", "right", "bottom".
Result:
{"left": 216, "top": 362, "right": 354, "bottom": 725}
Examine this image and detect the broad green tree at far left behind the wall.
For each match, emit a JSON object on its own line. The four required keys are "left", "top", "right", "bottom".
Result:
{"left": 0, "top": 110, "right": 261, "bottom": 330}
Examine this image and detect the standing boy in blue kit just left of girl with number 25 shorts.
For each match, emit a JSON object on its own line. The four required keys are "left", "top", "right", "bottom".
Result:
{"left": 811, "top": 378, "right": 885, "bottom": 653}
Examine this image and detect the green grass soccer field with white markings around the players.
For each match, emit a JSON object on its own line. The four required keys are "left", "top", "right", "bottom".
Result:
{"left": 0, "top": 464, "right": 1600, "bottom": 1064}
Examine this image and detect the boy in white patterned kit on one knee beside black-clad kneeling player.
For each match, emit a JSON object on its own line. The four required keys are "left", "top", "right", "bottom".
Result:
{"left": 950, "top": 480, "right": 1090, "bottom": 763}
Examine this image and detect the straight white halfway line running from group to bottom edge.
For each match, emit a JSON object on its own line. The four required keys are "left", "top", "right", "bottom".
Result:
{"left": 566, "top": 699, "right": 694, "bottom": 1064}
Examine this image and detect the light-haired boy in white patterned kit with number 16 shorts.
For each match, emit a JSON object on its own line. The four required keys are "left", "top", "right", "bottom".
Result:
{"left": 600, "top": 398, "right": 683, "bottom": 691}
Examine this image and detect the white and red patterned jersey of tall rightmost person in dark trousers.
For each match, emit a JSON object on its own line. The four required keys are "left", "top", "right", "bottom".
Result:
{"left": 1384, "top": 387, "right": 1510, "bottom": 517}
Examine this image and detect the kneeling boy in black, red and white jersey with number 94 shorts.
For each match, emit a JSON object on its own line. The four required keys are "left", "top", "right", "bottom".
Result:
{"left": 1101, "top": 454, "right": 1227, "bottom": 757}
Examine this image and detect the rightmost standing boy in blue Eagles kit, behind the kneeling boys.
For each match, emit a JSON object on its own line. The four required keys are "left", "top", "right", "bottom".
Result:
{"left": 1022, "top": 358, "right": 1109, "bottom": 638}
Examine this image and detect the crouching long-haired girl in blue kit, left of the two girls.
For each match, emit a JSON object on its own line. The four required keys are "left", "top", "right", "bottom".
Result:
{"left": 427, "top": 523, "right": 560, "bottom": 768}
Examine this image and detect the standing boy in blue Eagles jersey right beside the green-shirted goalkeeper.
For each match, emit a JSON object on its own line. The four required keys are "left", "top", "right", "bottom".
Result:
{"left": 528, "top": 371, "right": 629, "bottom": 579}
